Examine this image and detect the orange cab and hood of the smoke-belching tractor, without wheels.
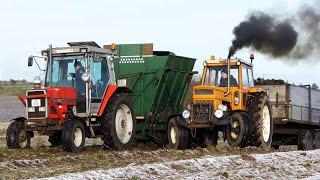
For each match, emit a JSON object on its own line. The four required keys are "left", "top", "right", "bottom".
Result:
{"left": 193, "top": 56, "right": 257, "bottom": 110}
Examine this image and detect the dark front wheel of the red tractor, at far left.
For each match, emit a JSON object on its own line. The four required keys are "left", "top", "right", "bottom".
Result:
{"left": 6, "top": 120, "right": 30, "bottom": 149}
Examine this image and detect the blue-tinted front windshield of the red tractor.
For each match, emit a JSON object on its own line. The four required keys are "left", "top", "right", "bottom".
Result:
{"left": 46, "top": 56, "right": 85, "bottom": 87}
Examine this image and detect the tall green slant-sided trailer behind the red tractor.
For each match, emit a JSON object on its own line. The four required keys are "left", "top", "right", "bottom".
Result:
{"left": 104, "top": 44, "right": 196, "bottom": 145}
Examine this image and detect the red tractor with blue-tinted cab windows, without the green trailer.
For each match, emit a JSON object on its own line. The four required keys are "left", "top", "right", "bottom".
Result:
{"left": 6, "top": 42, "right": 136, "bottom": 152}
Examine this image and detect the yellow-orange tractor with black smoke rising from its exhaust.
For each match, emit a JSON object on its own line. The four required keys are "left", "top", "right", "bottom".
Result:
{"left": 168, "top": 54, "right": 273, "bottom": 149}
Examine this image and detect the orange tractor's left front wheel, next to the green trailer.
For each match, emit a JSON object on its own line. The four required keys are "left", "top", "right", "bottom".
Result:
{"left": 167, "top": 118, "right": 191, "bottom": 150}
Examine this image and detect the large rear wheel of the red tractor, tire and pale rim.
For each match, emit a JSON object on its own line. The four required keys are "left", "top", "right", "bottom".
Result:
{"left": 101, "top": 96, "right": 136, "bottom": 149}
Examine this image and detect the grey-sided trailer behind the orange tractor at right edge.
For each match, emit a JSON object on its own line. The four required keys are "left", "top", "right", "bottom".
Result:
{"left": 259, "top": 81, "right": 320, "bottom": 150}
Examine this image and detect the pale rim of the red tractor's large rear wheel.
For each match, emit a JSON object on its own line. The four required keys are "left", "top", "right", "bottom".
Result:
{"left": 115, "top": 104, "right": 133, "bottom": 144}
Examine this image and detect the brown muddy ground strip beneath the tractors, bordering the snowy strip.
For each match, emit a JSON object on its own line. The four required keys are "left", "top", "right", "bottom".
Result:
{"left": 0, "top": 124, "right": 286, "bottom": 179}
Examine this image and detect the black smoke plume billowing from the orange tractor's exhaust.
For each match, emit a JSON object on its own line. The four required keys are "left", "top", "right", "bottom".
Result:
{"left": 228, "top": 1, "right": 320, "bottom": 59}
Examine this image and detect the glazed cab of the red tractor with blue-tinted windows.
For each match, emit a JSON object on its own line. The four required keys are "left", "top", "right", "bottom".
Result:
{"left": 42, "top": 42, "right": 115, "bottom": 116}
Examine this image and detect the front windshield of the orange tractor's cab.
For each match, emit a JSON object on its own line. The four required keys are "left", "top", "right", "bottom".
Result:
{"left": 203, "top": 66, "right": 238, "bottom": 87}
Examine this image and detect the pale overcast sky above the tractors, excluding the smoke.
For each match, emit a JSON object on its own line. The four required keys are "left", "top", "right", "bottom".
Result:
{"left": 0, "top": 0, "right": 320, "bottom": 84}
